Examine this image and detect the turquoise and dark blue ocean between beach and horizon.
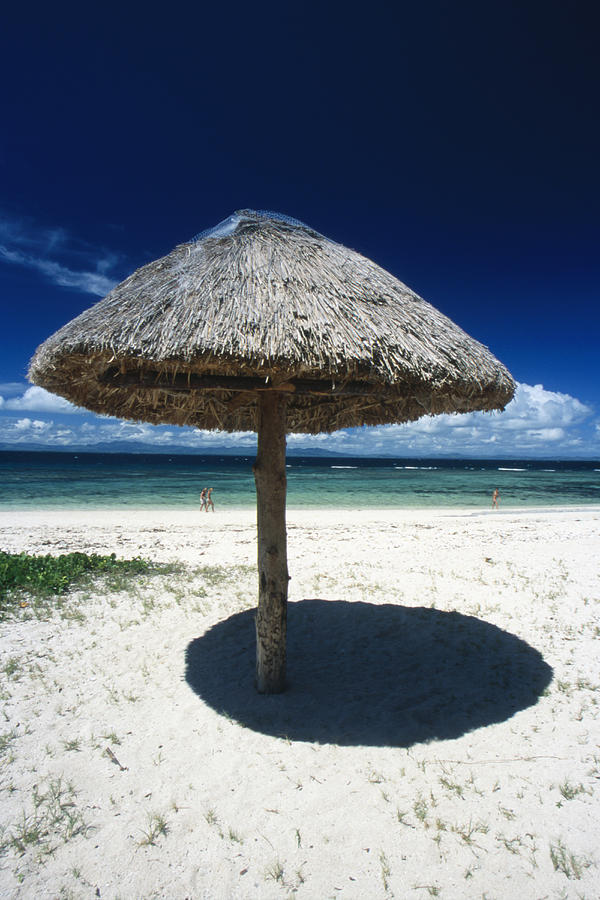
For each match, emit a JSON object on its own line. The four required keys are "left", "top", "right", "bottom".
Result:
{"left": 0, "top": 451, "right": 600, "bottom": 510}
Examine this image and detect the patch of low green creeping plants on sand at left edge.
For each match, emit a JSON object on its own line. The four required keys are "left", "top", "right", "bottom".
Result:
{"left": 0, "top": 551, "right": 175, "bottom": 619}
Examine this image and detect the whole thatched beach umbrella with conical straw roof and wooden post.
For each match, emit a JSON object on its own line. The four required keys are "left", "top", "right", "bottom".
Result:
{"left": 29, "top": 210, "right": 514, "bottom": 693}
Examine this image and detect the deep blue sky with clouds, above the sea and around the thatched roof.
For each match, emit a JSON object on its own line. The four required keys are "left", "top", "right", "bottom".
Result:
{"left": 0, "top": 0, "right": 600, "bottom": 458}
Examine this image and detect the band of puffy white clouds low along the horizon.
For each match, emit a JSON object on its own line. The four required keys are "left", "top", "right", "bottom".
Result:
{"left": 0, "top": 384, "right": 600, "bottom": 458}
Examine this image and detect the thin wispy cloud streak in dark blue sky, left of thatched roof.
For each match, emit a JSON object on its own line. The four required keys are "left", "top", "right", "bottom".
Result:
{"left": 0, "top": 217, "right": 117, "bottom": 297}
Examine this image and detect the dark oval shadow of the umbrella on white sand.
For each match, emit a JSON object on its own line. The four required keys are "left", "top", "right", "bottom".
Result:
{"left": 186, "top": 600, "right": 552, "bottom": 747}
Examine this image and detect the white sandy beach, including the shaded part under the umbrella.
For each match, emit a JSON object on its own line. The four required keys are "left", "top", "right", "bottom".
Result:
{"left": 0, "top": 508, "right": 600, "bottom": 900}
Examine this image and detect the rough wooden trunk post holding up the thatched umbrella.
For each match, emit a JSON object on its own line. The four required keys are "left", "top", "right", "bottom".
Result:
{"left": 254, "top": 392, "right": 289, "bottom": 694}
